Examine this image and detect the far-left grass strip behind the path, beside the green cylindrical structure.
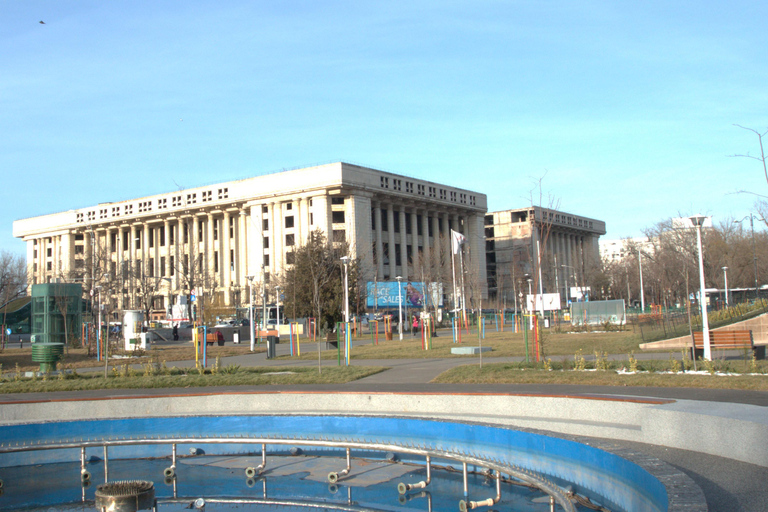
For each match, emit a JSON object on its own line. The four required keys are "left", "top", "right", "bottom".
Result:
{"left": 0, "top": 342, "right": 267, "bottom": 373}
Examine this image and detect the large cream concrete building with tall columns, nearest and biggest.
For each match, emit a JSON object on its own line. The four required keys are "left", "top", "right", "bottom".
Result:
{"left": 13, "top": 162, "right": 487, "bottom": 316}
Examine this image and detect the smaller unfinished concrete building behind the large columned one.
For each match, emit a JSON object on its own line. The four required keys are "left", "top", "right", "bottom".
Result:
{"left": 485, "top": 206, "right": 605, "bottom": 307}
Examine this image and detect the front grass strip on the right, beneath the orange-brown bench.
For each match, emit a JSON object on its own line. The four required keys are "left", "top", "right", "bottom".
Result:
{"left": 432, "top": 361, "right": 768, "bottom": 391}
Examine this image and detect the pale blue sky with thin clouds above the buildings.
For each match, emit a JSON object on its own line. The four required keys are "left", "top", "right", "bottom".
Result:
{"left": 0, "top": 0, "right": 768, "bottom": 253}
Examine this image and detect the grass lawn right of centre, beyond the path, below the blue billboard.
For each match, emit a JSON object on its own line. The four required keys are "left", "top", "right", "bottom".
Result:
{"left": 285, "top": 329, "right": 642, "bottom": 359}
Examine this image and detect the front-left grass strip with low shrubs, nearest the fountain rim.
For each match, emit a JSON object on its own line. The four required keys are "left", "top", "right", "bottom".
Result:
{"left": 0, "top": 365, "right": 385, "bottom": 393}
